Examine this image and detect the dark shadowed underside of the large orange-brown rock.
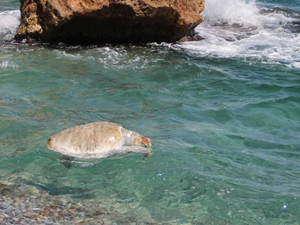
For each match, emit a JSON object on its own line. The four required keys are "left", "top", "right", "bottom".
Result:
{"left": 42, "top": 6, "right": 179, "bottom": 45}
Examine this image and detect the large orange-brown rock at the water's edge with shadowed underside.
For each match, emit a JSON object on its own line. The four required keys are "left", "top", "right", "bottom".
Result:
{"left": 16, "top": 0, "right": 204, "bottom": 44}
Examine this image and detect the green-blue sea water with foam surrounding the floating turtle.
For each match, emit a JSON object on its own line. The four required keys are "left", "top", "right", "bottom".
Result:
{"left": 0, "top": 0, "right": 300, "bottom": 224}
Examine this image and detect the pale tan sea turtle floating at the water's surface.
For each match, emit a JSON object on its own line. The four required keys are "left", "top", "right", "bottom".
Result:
{"left": 47, "top": 122, "right": 151, "bottom": 158}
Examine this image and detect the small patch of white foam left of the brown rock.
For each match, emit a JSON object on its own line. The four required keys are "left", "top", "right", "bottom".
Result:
{"left": 0, "top": 10, "right": 20, "bottom": 40}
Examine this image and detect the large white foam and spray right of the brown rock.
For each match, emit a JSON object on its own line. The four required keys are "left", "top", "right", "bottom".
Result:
{"left": 182, "top": 0, "right": 300, "bottom": 68}
